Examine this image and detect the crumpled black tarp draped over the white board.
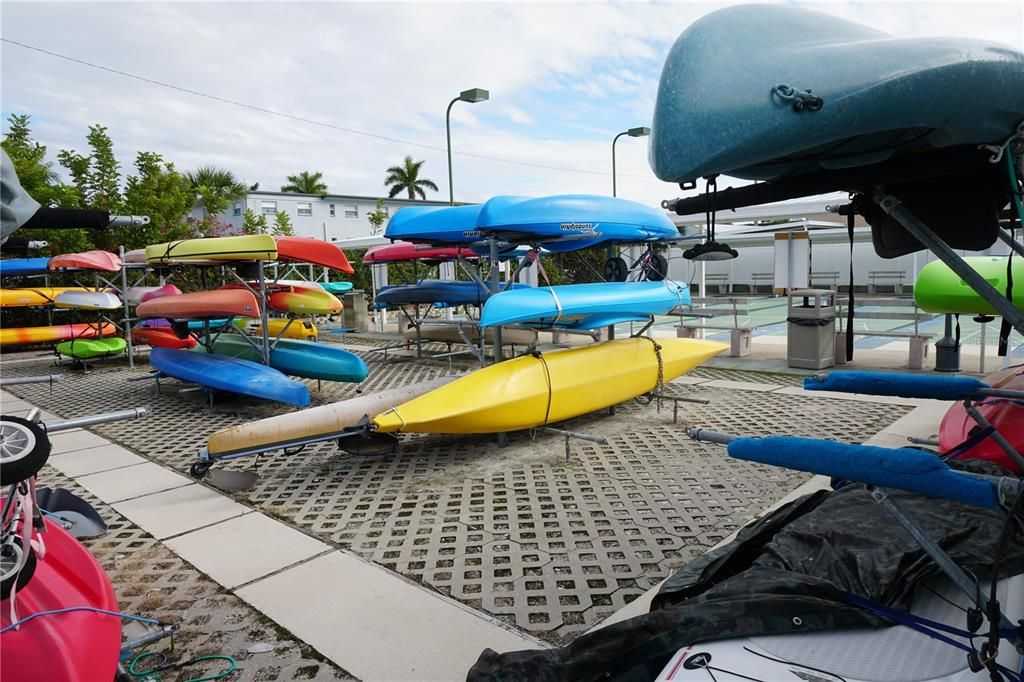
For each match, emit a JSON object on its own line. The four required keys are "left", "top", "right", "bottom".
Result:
{"left": 468, "top": 462, "right": 1024, "bottom": 682}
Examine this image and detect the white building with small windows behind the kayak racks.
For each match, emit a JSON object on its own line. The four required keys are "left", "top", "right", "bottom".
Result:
{"left": 193, "top": 189, "right": 447, "bottom": 242}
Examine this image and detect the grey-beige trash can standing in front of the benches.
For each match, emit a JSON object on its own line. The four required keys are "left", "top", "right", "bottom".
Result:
{"left": 785, "top": 289, "right": 836, "bottom": 370}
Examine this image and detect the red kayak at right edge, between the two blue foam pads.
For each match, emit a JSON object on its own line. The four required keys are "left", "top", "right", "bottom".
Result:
{"left": 939, "top": 366, "right": 1024, "bottom": 475}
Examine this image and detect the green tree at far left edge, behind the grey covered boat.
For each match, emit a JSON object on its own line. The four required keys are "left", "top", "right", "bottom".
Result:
{"left": 0, "top": 114, "right": 87, "bottom": 255}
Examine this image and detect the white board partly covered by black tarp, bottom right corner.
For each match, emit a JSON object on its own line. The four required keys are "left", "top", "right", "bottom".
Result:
{"left": 657, "top": 576, "right": 1024, "bottom": 682}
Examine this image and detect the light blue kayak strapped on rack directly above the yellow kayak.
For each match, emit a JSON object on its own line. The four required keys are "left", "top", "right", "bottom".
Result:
{"left": 480, "top": 280, "right": 690, "bottom": 329}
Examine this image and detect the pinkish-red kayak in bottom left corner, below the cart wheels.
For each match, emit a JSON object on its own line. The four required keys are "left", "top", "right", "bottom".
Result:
{"left": 0, "top": 519, "right": 121, "bottom": 682}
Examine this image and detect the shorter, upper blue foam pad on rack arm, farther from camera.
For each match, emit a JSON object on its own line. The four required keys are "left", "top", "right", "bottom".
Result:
{"left": 804, "top": 372, "right": 989, "bottom": 400}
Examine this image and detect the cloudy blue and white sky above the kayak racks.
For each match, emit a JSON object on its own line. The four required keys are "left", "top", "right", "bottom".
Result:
{"left": 0, "top": 0, "right": 1024, "bottom": 205}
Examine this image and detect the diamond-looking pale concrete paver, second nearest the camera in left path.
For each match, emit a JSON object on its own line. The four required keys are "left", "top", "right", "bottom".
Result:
{"left": 167, "top": 514, "right": 333, "bottom": 588}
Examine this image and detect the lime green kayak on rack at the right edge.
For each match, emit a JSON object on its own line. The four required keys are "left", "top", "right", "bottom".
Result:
{"left": 913, "top": 256, "right": 1024, "bottom": 315}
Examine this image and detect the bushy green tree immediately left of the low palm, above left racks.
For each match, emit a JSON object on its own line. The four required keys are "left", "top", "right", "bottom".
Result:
{"left": 115, "top": 152, "right": 195, "bottom": 249}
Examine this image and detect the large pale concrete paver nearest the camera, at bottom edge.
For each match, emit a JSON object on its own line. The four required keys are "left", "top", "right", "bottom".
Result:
{"left": 237, "top": 552, "right": 542, "bottom": 680}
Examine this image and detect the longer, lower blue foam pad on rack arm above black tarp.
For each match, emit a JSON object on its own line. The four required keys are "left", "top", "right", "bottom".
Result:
{"left": 729, "top": 436, "right": 999, "bottom": 507}
